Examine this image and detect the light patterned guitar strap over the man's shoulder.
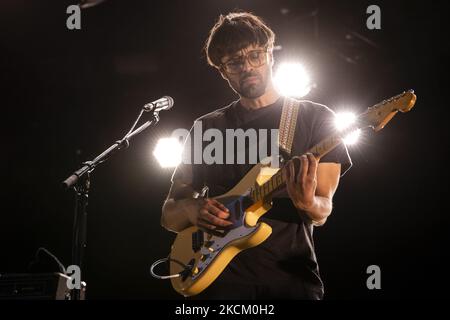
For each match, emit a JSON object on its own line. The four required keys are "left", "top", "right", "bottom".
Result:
{"left": 278, "top": 97, "right": 300, "bottom": 157}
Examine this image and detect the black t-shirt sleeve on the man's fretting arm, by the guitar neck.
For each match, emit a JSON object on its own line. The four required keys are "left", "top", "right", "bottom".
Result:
{"left": 310, "top": 105, "right": 352, "bottom": 177}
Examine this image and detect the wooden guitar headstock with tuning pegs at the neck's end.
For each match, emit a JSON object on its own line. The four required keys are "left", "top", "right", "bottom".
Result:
{"left": 358, "top": 90, "right": 417, "bottom": 131}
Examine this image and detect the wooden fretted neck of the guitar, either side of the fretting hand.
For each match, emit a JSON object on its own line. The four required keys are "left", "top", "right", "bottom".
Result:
{"left": 251, "top": 129, "right": 344, "bottom": 202}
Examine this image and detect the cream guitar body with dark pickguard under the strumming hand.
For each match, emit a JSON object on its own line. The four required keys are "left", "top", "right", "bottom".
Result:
{"left": 170, "top": 164, "right": 272, "bottom": 296}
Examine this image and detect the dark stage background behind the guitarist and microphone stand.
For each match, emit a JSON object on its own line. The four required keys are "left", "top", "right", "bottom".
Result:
{"left": 0, "top": 0, "right": 449, "bottom": 299}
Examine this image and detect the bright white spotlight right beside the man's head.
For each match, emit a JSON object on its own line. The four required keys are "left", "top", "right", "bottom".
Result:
{"left": 273, "top": 63, "right": 312, "bottom": 98}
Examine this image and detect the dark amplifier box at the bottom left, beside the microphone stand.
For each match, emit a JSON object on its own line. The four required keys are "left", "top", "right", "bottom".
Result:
{"left": 0, "top": 272, "right": 74, "bottom": 300}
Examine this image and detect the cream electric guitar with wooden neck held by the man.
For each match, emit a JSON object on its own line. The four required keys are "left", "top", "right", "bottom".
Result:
{"left": 169, "top": 90, "right": 416, "bottom": 296}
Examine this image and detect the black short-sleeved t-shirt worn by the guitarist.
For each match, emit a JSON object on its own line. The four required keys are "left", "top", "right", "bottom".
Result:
{"left": 172, "top": 98, "right": 351, "bottom": 299}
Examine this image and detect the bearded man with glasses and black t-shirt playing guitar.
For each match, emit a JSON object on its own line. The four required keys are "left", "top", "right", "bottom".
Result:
{"left": 161, "top": 12, "right": 351, "bottom": 299}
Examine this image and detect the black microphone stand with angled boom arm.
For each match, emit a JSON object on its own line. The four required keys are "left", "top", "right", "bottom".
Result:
{"left": 63, "top": 108, "right": 159, "bottom": 300}
